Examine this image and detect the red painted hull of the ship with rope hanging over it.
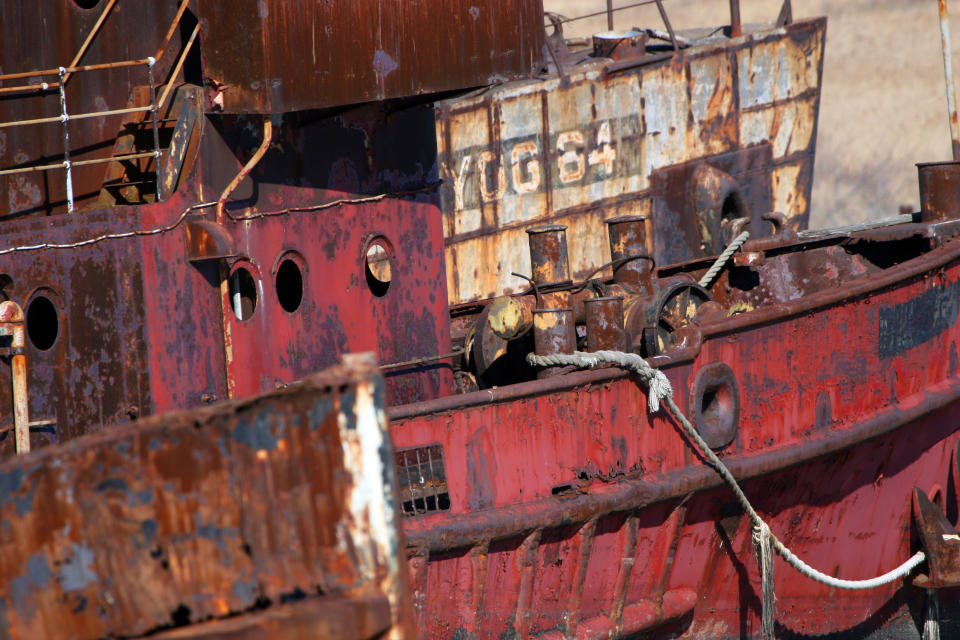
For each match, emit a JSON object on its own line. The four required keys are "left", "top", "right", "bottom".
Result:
{"left": 391, "top": 238, "right": 960, "bottom": 638}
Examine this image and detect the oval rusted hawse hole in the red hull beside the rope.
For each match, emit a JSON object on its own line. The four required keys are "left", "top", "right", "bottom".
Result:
{"left": 691, "top": 362, "right": 740, "bottom": 449}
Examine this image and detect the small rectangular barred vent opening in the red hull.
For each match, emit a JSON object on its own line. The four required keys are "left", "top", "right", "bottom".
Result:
{"left": 396, "top": 444, "right": 450, "bottom": 516}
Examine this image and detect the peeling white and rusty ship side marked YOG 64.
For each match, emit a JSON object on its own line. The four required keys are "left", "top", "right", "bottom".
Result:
{"left": 437, "top": 19, "right": 826, "bottom": 304}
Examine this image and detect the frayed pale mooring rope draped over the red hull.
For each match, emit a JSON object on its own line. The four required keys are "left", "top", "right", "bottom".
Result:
{"left": 527, "top": 350, "right": 926, "bottom": 638}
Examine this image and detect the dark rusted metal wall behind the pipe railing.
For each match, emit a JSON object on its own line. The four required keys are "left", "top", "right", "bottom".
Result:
{"left": 0, "top": 0, "right": 180, "bottom": 220}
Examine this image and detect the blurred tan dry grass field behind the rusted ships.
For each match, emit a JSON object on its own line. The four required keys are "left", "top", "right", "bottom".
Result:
{"left": 544, "top": 0, "right": 960, "bottom": 227}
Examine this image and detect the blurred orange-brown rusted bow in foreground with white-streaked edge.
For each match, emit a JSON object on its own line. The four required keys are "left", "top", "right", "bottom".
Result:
{"left": 0, "top": 356, "right": 407, "bottom": 638}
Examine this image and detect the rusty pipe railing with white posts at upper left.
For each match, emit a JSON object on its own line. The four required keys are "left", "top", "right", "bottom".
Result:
{"left": 0, "top": 0, "right": 200, "bottom": 213}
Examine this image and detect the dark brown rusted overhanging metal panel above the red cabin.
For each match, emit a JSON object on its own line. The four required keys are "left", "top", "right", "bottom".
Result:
{"left": 198, "top": 0, "right": 543, "bottom": 113}
